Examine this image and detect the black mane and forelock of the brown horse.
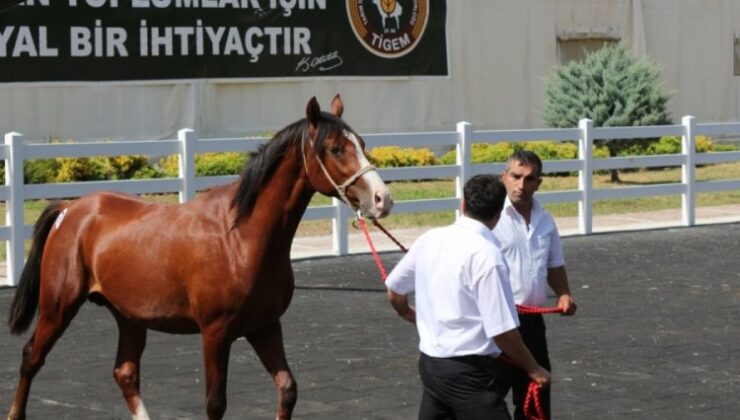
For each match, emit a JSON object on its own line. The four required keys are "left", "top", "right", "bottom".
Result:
{"left": 231, "top": 112, "right": 351, "bottom": 226}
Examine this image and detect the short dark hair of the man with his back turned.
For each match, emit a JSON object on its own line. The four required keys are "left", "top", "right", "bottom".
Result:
{"left": 463, "top": 174, "right": 506, "bottom": 220}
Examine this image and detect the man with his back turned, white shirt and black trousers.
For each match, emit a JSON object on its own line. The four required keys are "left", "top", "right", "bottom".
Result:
{"left": 386, "top": 175, "right": 550, "bottom": 420}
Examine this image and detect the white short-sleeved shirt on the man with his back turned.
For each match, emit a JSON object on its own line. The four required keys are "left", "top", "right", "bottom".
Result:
{"left": 385, "top": 216, "right": 519, "bottom": 357}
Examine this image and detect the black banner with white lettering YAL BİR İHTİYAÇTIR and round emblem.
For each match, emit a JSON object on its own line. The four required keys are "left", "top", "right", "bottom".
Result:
{"left": 0, "top": 0, "right": 448, "bottom": 83}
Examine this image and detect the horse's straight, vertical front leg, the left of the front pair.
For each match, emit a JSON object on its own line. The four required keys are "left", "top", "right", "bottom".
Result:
{"left": 203, "top": 326, "right": 231, "bottom": 420}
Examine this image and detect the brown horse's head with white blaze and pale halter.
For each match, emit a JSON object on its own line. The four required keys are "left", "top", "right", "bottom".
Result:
{"left": 301, "top": 95, "right": 393, "bottom": 219}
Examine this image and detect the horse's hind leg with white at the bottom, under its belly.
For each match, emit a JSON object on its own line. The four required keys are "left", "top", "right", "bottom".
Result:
{"left": 113, "top": 313, "right": 149, "bottom": 420}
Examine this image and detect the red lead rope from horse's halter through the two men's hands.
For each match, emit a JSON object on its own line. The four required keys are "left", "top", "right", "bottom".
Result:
{"left": 357, "top": 217, "right": 563, "bottom": 420}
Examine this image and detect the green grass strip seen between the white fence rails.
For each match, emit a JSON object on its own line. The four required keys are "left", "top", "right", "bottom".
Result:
{"left": 0, "top": 162, "right": 740, "bottom": 259}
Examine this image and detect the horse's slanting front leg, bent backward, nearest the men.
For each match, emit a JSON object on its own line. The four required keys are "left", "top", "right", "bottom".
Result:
{"left": 247, "top": 320, "right": 298, "bottom": 420}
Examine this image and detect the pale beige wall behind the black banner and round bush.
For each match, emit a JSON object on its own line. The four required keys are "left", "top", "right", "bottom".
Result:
{"left": 0, "top": 0, "right": 740, "bottom": 140}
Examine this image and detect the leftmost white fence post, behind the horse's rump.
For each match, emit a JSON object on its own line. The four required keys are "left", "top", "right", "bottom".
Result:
{"left": 5, "top": 132, "right": 26, "bottom": 286}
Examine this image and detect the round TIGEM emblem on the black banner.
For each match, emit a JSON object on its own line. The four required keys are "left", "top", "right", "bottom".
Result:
{"left": 347, "top": 0, "right": 429, "bottom": 58}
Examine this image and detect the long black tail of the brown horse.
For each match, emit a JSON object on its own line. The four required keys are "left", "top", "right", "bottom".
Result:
{"left": 8, "top": 202, "right": 62, "bottom": 335}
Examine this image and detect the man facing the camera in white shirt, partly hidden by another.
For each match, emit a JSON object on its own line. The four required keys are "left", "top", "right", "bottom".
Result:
{"left": 493, "top": 150, "right": 576, "bottom": 419}
